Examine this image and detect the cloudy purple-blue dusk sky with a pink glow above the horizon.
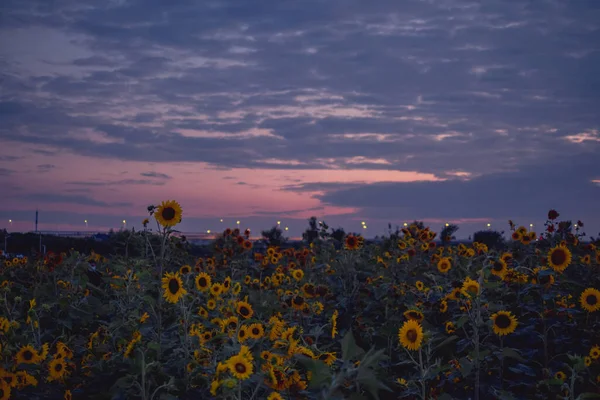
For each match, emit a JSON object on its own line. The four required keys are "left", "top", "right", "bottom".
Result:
{"left": 0, "top": 0, "right": 600, "bottom": 238}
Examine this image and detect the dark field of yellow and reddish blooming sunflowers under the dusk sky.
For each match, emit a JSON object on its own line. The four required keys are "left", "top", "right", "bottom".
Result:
{"left": 0, "top": 201, "right": 600, "bottom": 400}
